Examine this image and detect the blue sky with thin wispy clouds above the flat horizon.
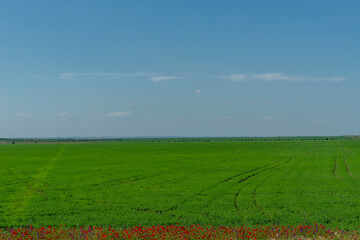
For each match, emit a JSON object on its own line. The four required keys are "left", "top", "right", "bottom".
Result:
{"left": 0, "top": 0, "right": 360, "bottom": 137}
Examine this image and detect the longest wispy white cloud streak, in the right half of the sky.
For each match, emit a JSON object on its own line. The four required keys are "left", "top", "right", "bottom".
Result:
{"left": 222, "top": 72, "right": 346, "bottom": 82}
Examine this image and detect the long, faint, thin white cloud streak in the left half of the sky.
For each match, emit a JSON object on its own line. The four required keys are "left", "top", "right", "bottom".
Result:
{"left": 59, "top": 72, "right": 156, "bottom": 80}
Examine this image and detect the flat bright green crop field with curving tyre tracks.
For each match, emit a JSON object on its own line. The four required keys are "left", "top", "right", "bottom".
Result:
{"left": 0, "top": 140, "right": 360, "bottom": 229}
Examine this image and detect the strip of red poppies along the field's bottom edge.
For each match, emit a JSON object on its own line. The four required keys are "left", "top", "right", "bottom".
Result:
{"left": 0, "top": 223, "right": 360, "bottom": 240}
